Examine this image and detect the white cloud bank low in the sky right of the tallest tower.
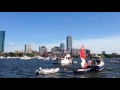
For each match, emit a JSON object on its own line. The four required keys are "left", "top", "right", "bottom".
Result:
{"left": 73, "top": 36, "right": 120, "bottom": 54}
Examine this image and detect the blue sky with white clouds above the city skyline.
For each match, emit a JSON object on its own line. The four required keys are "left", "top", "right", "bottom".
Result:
{"left": 0, "top": 12, "right": 120, "bottom": 54}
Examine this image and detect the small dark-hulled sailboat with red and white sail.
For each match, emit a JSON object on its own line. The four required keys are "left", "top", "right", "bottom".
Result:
{"left": 73, "top": 44, "right": 91, "bottom": 73}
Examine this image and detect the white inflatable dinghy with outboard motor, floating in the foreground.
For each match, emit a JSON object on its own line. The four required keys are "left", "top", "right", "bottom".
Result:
{"left": 35, "top": 67, "right": 60, "bottom": 74}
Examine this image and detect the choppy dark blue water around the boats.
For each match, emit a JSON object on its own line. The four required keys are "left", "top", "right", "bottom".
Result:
{"left": 0, "top": 58, "right": 120, "bottom": 78}
